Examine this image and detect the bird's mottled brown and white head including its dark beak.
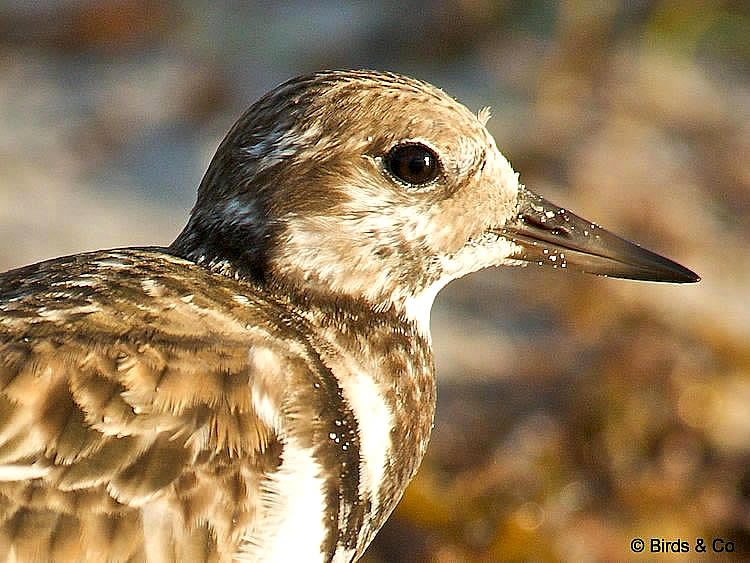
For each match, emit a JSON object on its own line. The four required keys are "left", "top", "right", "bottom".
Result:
{"left": 173, "top": 71, "right": 699, "bottom": 323}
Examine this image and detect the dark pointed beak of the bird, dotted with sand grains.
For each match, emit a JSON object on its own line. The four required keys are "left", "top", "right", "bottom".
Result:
{"left": 497, "top": 187, "right": 700, "bottom": 283}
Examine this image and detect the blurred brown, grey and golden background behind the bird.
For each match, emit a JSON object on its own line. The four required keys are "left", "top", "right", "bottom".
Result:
{"left": 0, "top": 0, "right": 750, "bottom": 563}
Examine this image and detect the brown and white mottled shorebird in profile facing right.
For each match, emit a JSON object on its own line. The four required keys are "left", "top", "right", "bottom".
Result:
{"left": 0, "top": 70, "right": 699, "bottom": 563}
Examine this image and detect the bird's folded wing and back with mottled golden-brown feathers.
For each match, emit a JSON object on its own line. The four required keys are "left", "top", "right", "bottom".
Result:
{"left": 0, "top": 250, "right": 302, "bottom": 561}
